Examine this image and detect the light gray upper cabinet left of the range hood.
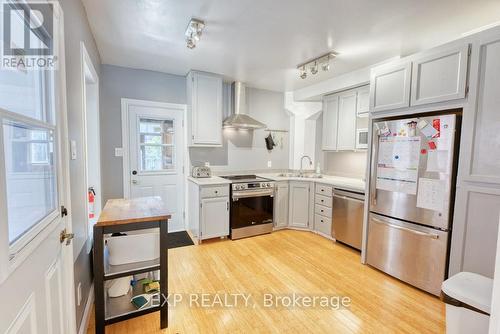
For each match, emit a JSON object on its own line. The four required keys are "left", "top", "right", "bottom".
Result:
{"left": 187, "top": 71, "right": 222, "bottom": 146}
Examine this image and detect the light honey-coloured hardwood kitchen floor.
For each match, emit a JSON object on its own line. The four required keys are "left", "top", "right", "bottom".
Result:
{"left": 88, "top": 230, "right": 445, "bottom": 334}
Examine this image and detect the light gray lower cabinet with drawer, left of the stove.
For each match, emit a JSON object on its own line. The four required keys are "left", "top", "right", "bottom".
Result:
{"left": 188, "top": 181, "right": 229, "bottom": 242}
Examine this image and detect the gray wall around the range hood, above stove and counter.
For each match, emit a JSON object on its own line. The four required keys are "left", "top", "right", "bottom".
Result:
{"left": 189, "top": 84, "right": 290, "bottom": 173}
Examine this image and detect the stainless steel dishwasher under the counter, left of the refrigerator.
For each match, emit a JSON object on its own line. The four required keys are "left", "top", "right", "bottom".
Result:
{"left": 332, "top": 189, "right": 365, "bottom": 250}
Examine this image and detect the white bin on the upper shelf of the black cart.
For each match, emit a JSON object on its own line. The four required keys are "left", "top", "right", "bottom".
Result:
{"left": 106, "top": 229, "right": 160, "bottom": 266}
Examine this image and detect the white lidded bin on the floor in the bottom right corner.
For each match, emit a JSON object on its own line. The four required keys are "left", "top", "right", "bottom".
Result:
{"left": 442, "top": 272, "right": 493, "bottom": 334}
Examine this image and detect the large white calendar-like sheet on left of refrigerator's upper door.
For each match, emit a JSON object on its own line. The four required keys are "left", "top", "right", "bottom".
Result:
{"left": 376, "top": 137, "right": 420, "bottom": 195}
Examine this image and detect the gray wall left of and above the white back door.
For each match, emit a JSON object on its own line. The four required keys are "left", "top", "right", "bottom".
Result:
{"left": 100, "top": 65, "right": 186, "bottom": 203}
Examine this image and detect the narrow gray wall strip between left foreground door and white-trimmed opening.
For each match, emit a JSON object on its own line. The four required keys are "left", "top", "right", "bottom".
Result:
{"left": 60, "top": 0, "right": 101, "bottom": 327}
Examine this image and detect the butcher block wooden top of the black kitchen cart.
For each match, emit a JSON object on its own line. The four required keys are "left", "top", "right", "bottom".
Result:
{"left": 96, "top": 196, "right": 171, "bottom": 226}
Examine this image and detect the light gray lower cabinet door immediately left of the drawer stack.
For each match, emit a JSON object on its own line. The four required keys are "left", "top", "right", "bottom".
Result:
{"left": 288, "top": 181, "right": 310, "bottom": 228}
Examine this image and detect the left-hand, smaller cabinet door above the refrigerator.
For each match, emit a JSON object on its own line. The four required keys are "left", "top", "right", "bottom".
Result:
{"left": 370, "top": 61, "right": 411, "bottom": 112}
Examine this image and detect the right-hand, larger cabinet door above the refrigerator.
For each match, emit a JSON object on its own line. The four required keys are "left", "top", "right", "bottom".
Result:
{"left": 411, "top": 44, "right": 469, "bottom": 106}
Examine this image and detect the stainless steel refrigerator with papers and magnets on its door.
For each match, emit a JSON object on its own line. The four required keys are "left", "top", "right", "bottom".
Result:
{"left": 367, "top": 113, "right": 460, "bottom": 295}
